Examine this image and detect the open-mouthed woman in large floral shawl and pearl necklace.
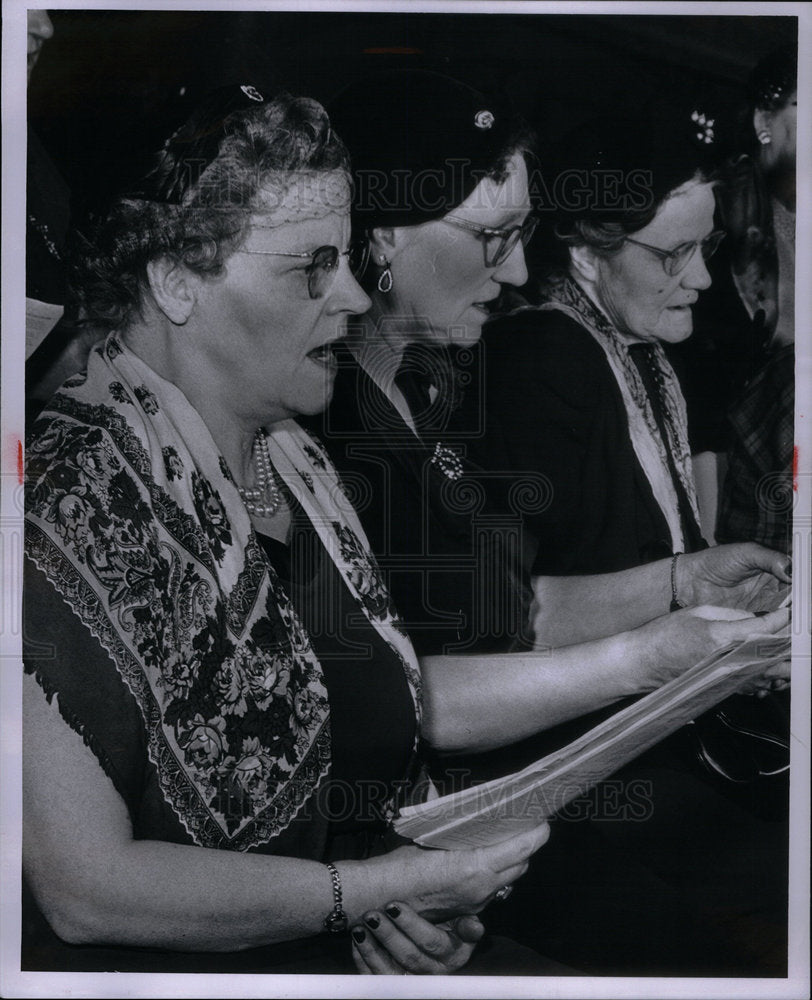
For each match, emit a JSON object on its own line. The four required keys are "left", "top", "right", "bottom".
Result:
{"left": 24, "top": 85, "right": 560, "bottom": 973}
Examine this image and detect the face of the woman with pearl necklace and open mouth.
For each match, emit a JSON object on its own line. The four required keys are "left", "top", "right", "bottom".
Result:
{"left": 199, "top": 172, "right": 370, "bottom": 424}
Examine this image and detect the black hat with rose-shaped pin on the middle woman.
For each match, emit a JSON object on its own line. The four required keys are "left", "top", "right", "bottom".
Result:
{"left": 328, "top": 69, "right": 515, "bottom": 229}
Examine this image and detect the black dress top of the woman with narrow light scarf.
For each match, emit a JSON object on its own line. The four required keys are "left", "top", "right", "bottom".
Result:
{"left": 456, "top": 310, "right": 704, "bottom": 576}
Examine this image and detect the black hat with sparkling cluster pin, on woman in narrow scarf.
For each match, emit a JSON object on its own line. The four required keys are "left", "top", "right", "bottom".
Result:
{"left": 542, "top": 104, "right": 722, "bottom": 231}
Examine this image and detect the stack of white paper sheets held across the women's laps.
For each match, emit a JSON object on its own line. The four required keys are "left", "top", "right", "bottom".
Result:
{"left": 395, "top": 629, "right": 791, "bottom": 850}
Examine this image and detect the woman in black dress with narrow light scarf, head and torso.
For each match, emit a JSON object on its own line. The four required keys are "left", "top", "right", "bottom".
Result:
{"left": 464, "top": 115, "right": 722, "bottom": 575}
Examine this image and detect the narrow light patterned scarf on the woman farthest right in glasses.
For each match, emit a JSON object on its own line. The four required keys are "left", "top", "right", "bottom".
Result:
{"left": 534, "top": 277, "right": 699, "bottom": 552}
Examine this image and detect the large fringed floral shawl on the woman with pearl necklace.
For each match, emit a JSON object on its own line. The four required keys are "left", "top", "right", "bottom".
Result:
{"left": 26, "top": 333, "right": 420, "bottom": 850}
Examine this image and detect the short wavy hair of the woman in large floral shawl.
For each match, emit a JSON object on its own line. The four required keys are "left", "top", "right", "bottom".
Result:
{"left": 76, "top": 88, "right": 349, "bottom": 328}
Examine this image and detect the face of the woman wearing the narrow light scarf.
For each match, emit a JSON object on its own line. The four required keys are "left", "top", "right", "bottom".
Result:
{"left": 593, "top": 182, "right": 715, "bottom": 344}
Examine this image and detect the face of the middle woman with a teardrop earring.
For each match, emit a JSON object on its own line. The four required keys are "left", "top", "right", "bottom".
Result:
{"left": 379, "top": 153, "right": 530, "bottom": 344}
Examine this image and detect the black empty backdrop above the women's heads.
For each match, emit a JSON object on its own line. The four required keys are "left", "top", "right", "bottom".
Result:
{"left": 29, "top": 11, "right": 797, "bottom": 217}
